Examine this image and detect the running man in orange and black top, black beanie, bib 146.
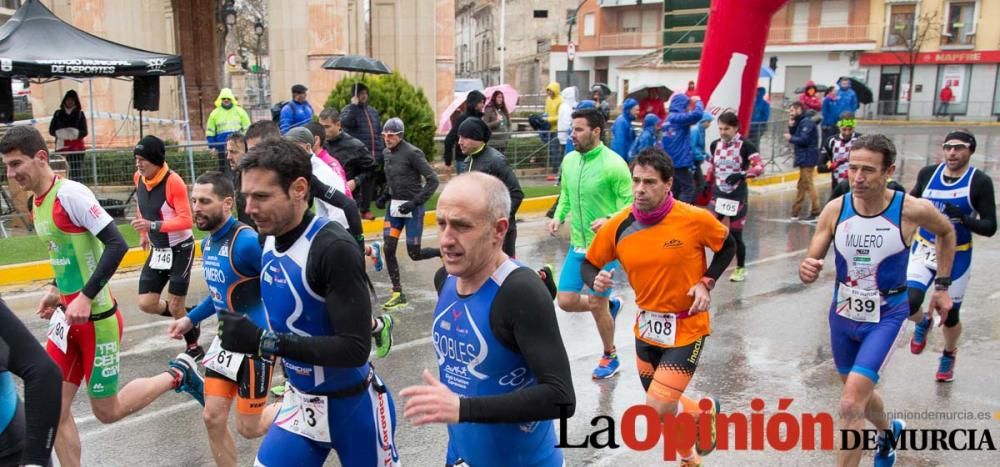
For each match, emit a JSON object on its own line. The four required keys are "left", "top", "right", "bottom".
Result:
{"left": 132, "top": 135, "right": 205, "bottom": 360}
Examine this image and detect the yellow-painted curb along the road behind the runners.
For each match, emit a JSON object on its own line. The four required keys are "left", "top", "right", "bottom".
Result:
{"left": 0, "top": 195, "right": 556, "bottom": 287}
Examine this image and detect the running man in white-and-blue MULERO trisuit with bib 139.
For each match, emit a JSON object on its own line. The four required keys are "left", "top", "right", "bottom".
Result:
{"left": 799, "top": 134, "right": 955, "bottom": 467}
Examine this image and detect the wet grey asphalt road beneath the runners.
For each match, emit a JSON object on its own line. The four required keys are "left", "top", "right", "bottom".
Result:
{"left": 4, "top": 128, "right": 1000, "bottom": 466}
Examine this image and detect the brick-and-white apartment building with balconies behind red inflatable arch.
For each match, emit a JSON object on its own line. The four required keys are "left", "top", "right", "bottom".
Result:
{"left": 553, "top": 0, "right": 876, "bottom": 108}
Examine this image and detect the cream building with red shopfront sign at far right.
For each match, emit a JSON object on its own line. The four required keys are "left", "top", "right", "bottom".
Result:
{"left": 860, "top": 0, "right": 1000, "bottom": 120}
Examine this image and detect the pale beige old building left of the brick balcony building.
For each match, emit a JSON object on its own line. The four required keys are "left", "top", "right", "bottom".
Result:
{"left": 455, "top": 0, "right": 579, "bottom": 94}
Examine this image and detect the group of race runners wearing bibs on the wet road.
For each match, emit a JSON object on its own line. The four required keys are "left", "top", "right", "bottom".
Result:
{"left": 0, "top": 100, "right": 996, "bottom": 466}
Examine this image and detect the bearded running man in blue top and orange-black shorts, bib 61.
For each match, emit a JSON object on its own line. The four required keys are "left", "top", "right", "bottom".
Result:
{"left": 167, "top": 173, "right": 280, "bottom": 466}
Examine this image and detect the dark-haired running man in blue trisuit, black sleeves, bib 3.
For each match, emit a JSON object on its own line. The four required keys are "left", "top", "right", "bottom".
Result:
{"left": 221, "top": 140, "right": 399, "bottom": 466}
